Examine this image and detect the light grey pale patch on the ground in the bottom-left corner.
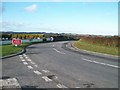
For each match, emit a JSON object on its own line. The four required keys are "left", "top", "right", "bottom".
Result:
{"left": 0, "top": 78, "right": 21, "bottom": 90}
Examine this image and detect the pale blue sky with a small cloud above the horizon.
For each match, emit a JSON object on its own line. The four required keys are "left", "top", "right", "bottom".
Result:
{"left": 2, "top": 2, "right": 118, "bottom": 35}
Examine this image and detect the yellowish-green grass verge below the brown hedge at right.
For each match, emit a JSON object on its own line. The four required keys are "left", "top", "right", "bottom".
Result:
{"left": 74, "top": 41, "right": 118, "bottom": 56}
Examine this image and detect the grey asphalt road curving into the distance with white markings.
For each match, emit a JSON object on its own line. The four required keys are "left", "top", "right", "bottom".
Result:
{"left": 2, "top": 42, "right": 119, "bottom": 88}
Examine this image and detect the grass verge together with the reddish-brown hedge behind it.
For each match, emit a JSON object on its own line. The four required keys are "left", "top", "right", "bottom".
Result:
{"left": 74, "top": 36, "right": 120, "bottom": 56}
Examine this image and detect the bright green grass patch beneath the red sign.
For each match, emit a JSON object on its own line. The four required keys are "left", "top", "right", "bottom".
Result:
{"left": 0, "top": 43, "right": 30, "bottom": 57}
